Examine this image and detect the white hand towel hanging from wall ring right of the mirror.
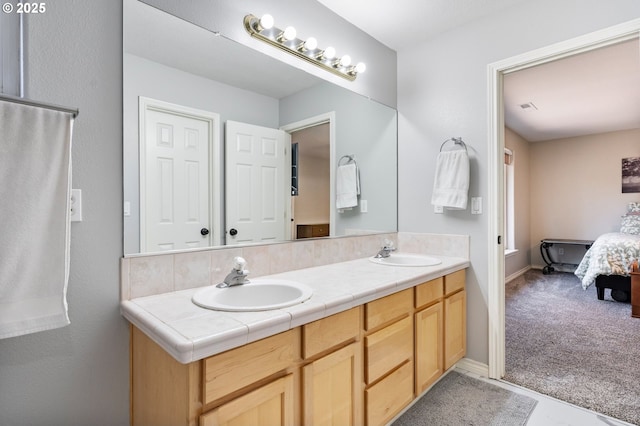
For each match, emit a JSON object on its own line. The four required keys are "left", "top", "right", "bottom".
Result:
{"left": 431, "top": 149, "right": 469, "bottom": 209}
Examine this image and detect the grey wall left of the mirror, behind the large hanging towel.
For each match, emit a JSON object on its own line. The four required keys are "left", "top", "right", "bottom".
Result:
{"left": 0, "top": 0, "right": 129, "bottom": 426}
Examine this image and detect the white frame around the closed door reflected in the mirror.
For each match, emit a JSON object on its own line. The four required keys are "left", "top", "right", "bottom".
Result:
{"left": 138, "top": 96, "right": 223, "bottom": 253}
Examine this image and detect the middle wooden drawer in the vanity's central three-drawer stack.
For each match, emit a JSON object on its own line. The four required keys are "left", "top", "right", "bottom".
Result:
{"left": 364, "top": 317, "right": 413, "bottom": 385}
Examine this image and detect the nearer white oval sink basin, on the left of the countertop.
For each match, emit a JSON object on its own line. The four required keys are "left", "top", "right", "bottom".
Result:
{"left": 191, "top": 278, "right": 313, "bottom": 312}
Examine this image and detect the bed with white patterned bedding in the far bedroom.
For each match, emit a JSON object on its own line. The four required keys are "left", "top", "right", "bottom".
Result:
{"left": 575, "top": 203, "right": 640, "bottom": 302}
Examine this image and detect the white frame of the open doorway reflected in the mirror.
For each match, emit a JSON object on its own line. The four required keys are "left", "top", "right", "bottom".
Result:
{"left": 280, "top": 111, "right": 336, "bottom": 237}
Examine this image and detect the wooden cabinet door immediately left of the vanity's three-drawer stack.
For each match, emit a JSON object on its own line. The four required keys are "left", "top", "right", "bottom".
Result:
{"left": 302, "top": 343, "right": 362, "bottom": 426}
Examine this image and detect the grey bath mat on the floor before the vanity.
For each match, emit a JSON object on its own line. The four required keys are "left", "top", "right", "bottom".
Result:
{"left": 393, "top": 371, "right": 537, "bottom": 426}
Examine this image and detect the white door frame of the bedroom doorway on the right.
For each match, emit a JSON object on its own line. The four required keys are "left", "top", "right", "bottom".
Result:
{"left": 487, "top": 19, "right": 640, "bottom": 379}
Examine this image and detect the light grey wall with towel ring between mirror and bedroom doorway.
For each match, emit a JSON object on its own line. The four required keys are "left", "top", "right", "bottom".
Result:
{"left": 398, "top": 0, "right": 640, "bottom": 363}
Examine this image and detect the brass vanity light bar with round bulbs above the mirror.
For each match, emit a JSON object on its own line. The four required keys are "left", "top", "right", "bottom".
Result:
{"left": 244, "top": 15, "right": 367, "bottom": 81}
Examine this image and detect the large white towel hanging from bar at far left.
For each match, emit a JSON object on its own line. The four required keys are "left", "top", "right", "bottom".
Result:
{"left": 0, "top": 101, "right": 73, "bottom": 338}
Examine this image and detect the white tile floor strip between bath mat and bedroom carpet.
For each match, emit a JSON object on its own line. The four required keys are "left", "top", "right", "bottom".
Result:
{"left": 456, "top": 367, "right": 633, "bottom": 426}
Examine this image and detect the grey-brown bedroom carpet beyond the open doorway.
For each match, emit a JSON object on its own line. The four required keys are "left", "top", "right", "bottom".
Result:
{"left": 504, "top": 270, "right": 640, "bottom": 425}
